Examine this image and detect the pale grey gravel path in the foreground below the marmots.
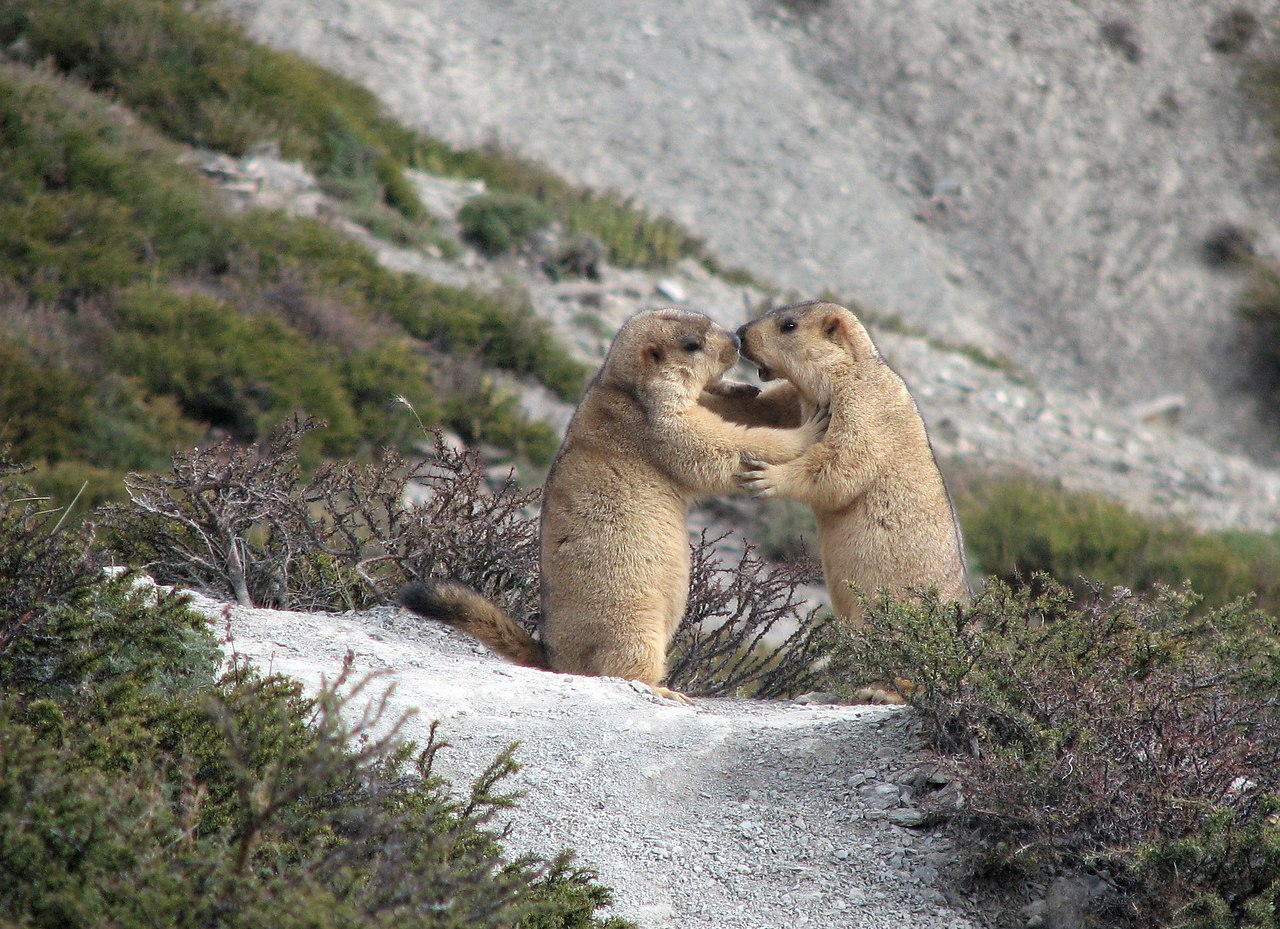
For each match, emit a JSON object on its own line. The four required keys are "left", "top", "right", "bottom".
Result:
{"left": 195, "top": 596, "right": 982, "bottom": 929}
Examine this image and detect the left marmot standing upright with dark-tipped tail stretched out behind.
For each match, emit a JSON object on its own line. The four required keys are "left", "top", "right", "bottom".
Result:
{"left": 401, "top": 310, "right": 824, "bottom": 699}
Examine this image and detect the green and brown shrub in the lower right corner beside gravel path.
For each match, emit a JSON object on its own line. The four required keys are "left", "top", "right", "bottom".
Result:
{"left": 831, "top": 577, "right": 1280, "bottom": 926}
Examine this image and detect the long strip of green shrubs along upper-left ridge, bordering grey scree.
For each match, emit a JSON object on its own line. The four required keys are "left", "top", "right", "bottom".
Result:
{"left": 0, "top": 0, "right": 701, "bottom": 272}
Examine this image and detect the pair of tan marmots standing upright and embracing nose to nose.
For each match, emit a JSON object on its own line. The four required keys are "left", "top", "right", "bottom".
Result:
{"left": 401, "top": 303, "right": 969, "bottom": 696}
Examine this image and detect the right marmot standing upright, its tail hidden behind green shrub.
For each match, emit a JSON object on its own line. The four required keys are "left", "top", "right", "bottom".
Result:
{"left": 737, "top": 301, "right": 972, "bottom": 622}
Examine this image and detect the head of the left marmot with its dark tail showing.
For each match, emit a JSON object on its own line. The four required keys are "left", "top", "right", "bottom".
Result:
{"left": 600, "top": 308, "right": 739, "bottom": 404}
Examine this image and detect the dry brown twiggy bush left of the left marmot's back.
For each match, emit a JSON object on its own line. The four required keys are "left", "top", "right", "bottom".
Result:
{"left": 102, "top": 417, "right": 538, "bottom": 617}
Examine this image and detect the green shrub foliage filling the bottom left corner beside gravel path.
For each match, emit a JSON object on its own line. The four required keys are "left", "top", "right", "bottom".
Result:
{"left": 0, "top": 455, "right": 630, "bottom": 929}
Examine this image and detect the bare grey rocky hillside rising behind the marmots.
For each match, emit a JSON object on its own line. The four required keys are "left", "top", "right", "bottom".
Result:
{"left": 223, "top": 0, "right": 1280, "bottom": 528}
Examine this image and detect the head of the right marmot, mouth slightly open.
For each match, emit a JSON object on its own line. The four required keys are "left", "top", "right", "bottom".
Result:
{"left": 737, "top": 301, "right": 879, "bottom": 398}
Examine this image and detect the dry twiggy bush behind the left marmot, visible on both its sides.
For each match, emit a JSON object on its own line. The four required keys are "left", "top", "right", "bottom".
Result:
{"left": 101, "top": 417, "right": 829, "bottom": 697}
